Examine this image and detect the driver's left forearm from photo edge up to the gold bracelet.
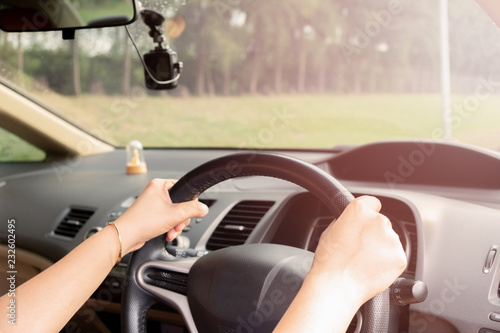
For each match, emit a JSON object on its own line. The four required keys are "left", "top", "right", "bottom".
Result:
{"left": 0, "top": 226, "right": 120, "bottom": 332}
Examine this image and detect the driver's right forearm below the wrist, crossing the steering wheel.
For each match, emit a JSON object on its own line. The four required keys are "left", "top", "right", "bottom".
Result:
{"left": 274, "top": 274, "right": 362, "bottom": 333}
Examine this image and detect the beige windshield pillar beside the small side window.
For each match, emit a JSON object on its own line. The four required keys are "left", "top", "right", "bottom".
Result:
{"left": 0, "top": 84, "right": 114, "bottom": 156}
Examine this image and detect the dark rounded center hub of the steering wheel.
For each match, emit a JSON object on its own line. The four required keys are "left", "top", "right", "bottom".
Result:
{"left": 188, "top": 244, "right": 313, "bottom": 332}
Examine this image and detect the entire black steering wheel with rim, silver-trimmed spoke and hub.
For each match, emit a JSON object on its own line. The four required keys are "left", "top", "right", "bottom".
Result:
{"left": 121, "top": 153, "right": 390, "bottom": 333}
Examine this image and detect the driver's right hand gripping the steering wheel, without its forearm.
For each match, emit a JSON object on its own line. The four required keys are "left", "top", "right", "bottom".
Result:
{"left": 309, "top": 196, "right": 407, "bottom": 303}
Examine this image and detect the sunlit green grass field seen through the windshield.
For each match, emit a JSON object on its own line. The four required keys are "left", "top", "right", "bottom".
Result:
{"left": 2, "top": 93, "right": 500, "bottom": 161}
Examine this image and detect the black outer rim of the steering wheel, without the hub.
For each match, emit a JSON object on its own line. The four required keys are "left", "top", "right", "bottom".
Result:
{"left": 121, "top": 152, "right": 389, "bottom": 333}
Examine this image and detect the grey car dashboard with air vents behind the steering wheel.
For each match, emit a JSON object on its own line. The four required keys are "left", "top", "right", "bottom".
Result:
{"left": 0, "top": 141, "right": 500, "bottom": 333}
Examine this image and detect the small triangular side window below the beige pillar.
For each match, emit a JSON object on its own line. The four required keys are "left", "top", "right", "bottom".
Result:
{"left": 0, "top": 127, "right": 45, "bottom": 162}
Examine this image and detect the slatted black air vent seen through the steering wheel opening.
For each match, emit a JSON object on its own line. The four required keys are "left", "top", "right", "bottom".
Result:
{"left": 207, "top": 201, "right": 274, "bottom": 251}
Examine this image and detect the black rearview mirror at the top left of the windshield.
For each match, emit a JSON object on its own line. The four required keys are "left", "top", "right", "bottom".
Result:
{"left": 0, "top": 0, "right": 136, "bottom": 35}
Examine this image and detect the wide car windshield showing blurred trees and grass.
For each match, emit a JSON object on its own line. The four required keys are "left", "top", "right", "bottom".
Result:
{"left": 0, "top": 0, "right": 500, "bottom": 149}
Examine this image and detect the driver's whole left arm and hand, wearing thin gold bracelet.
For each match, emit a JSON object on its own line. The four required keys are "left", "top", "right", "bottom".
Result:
{"left": 0, "top": 179, "right": 208, "bottom": 333}
